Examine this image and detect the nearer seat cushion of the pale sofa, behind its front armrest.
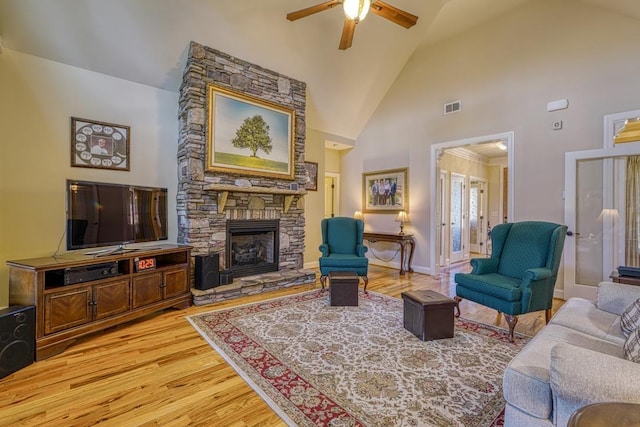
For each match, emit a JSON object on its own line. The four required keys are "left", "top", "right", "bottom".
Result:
{"left": 503, "top": 323, "right": 624, "bottom": 419}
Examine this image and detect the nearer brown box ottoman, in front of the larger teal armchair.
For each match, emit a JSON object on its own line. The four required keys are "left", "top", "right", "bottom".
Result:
{"left": 401, "top": 291, "right": 456, "bottom": 341}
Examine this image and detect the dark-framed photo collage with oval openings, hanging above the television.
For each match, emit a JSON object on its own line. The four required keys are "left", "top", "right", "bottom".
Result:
{"left": 71, "top": 117, "right": 131, "bottom": 171}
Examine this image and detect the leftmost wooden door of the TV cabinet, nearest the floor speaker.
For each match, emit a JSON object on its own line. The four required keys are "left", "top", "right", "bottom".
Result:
{"left": 44, "top": 287, "right": 92, "bottom": 335}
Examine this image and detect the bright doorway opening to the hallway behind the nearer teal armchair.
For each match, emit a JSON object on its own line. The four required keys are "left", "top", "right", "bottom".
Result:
{"left": 430, "top": 132, "right": 514, "bottom": 275}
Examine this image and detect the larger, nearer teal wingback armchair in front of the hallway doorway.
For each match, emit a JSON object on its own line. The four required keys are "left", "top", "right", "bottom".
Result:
{"left": 455, "top": 221, "right": 567, "bottom": 341}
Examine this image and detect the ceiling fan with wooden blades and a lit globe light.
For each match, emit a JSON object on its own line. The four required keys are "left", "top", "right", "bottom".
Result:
{"left": 287, "top": 0, "right": 418, "bottom": 50}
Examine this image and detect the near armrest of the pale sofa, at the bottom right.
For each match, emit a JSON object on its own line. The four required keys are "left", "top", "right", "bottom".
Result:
{"left": 549, "top": 343, "right": 640, "bottom": 418}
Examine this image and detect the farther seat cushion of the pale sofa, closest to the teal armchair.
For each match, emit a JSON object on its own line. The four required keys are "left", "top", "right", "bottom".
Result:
{"left": 551, "top": 298, "right": 626, "bottom": 346}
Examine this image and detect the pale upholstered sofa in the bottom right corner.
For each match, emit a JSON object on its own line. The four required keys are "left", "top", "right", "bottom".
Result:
{"left": 503, "top": 282, "right": 640, "bottom": 427}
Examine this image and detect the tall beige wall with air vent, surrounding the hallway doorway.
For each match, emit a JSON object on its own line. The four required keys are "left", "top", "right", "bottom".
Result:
{"left": 343, "top": 0, "right": 640, "bottom": 273}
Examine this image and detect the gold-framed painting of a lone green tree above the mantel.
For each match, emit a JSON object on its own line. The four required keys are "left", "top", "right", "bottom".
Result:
{"left": 207, "top": 85, "right": 295, "bottom": 179}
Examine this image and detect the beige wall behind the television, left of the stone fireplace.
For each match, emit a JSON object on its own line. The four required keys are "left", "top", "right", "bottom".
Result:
{"left": 0, "top": 49, "right": 178, "bottom": 306}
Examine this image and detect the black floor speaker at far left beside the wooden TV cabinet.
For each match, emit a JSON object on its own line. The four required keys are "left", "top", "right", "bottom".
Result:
{"left": 0, "top": 305, "right": 36, "bottom": 378}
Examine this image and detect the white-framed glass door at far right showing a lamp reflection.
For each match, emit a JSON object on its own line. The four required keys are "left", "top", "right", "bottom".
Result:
{"left": 563, "top": 143, "right": 640, "bottom": 300}
